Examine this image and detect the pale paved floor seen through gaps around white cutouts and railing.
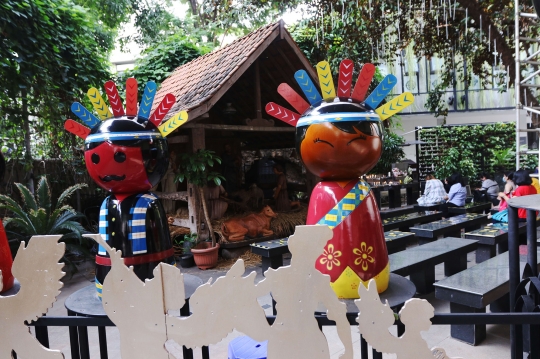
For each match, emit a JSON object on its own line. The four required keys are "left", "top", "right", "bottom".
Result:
{"left": 33, "top": 245, "right": 510, "bottom": 359}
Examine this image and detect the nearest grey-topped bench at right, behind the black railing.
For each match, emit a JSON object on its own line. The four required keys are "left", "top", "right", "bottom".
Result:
{"left": 435, "top": 253, "right": 540, "bottom": 345}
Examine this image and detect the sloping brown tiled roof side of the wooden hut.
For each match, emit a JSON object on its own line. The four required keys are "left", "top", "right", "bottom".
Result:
{"left": 154, "top": 21, "right": 282, "bottom": 119}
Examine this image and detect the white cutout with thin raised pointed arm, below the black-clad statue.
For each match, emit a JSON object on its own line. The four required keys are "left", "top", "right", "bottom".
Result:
{"left": 87, "top": 234, "right": 184, "bottom": 359}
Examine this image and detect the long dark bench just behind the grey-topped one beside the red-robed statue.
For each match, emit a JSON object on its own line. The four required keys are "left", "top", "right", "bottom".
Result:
{"left": 409, "top": 213, "right": 489, "bottom": 244}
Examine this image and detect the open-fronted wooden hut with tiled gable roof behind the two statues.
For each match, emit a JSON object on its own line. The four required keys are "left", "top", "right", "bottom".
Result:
{"left": 154, "top": 21, "right": 318, "bottom": 236}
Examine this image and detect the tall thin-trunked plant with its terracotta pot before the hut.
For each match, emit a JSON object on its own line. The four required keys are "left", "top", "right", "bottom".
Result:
{"left": 175, "top": 149, "right": 224, "bottom": 269}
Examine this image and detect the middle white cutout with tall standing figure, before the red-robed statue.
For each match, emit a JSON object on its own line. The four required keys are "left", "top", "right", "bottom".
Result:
{"left": 167, "top": 226, "right": 353, "bottom": 359}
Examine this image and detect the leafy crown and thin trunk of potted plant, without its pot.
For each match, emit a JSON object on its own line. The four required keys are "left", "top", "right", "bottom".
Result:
{"left": 174, "top": 149, "right": 225, "bottom": 247}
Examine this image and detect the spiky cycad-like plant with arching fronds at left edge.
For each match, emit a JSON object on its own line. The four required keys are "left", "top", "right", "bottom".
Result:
{"left": 0, "top": 177, "right": 89, "bottom": 270}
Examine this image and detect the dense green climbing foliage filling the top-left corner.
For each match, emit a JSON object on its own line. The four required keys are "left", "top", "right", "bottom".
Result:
{"left": 0, "top": 0, "right": 114, "bottom": 162}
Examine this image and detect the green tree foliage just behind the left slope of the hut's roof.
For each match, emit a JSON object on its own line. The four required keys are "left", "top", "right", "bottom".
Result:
{"left": 118, "top": 34, "right": 210, "bottom": 84}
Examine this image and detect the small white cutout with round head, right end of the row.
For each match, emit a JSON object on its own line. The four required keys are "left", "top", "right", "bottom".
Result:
{"left": 354, "top": 279, "right": 459, "bottom": 359}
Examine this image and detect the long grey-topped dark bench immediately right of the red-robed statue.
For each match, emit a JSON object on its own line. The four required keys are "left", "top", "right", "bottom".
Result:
{"left": 388, "top": 237, "right": 476, "bottom": 293}
